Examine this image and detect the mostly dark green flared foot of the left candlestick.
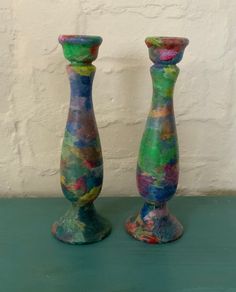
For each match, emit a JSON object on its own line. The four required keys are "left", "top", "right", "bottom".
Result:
{"left": 51, "top": 204, "right": 111, "bottom": 244}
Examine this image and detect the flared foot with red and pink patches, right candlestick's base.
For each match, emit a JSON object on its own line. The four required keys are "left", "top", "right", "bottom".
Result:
{"left": 125, "top": 203, "right": 183, "bottom": 244}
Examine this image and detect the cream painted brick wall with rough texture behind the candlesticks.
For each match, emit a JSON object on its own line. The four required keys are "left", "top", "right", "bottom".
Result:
{"left": 0, "top": 0, "right": 236, "bottom": 196}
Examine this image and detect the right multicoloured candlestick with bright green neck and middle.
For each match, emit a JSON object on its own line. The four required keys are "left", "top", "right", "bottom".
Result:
{"left": 126, "top": 37, "right": 188, "bottom": 243}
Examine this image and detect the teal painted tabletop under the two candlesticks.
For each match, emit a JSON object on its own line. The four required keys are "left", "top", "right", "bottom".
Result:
{"left": 0, "top": 196, "right": 236, "bottom": 292}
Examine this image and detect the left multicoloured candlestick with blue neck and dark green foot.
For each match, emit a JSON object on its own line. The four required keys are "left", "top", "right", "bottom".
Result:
{"left": 52, "top": 35, "right": 111, "bottom": 244}
